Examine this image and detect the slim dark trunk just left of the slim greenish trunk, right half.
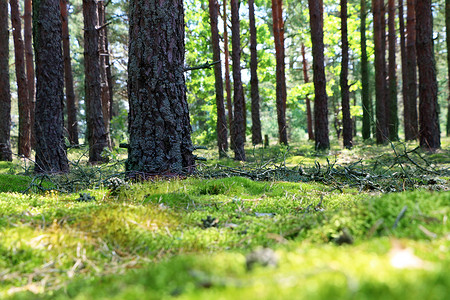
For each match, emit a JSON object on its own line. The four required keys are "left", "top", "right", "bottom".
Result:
{"left": 340, "top": 0, "right": 353, "bottom": 149}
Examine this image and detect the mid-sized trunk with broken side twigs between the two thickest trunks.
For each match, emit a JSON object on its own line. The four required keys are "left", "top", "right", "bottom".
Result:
{"left": 83, "top": 0, "right": 108, "bottom": 163}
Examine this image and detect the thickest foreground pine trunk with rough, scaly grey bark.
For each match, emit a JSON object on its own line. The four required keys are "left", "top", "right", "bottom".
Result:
{"left": 126, "top": 0, "right": 195, "bottom": 174}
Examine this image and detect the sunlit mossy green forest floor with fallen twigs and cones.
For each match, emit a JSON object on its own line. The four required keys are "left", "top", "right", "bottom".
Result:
{"left": 0, "top": 138, "right": 450, "bottom": 299}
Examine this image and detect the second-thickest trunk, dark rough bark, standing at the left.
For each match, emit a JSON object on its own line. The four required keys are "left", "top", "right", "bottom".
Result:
{"left": 33, "top": 0, "right": 69, "bottom": 173}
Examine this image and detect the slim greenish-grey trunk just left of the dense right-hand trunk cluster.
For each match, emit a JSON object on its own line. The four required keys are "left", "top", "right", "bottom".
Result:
{"left": 360, "top": 0, "right": 373, "bottom": 140}
